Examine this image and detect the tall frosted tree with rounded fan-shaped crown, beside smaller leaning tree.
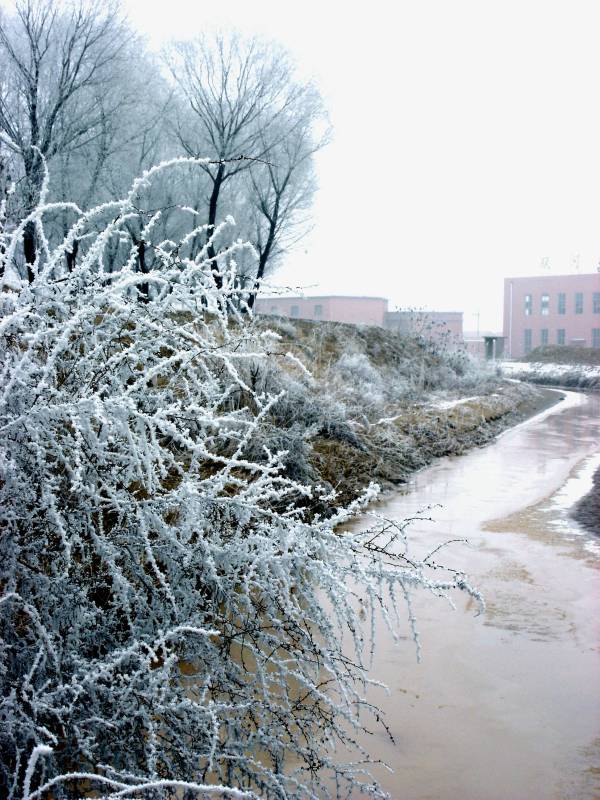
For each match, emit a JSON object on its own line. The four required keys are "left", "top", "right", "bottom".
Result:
{"left": 166, "top": 34, "right": 318, "bottom": 287}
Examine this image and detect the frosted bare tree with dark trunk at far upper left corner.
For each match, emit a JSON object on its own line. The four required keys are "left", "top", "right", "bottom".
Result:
{"left": 0, "top": 0, "right": 131, "bottom": 280}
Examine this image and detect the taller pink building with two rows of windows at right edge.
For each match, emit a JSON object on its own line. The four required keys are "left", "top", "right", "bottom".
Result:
{"left": 504, "top": 273, "right": 600, "bottom": 358}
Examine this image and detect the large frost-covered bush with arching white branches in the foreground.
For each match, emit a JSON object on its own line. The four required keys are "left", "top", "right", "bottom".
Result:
{"left": 0, "top": 160, "right": 482, "bottom": 800}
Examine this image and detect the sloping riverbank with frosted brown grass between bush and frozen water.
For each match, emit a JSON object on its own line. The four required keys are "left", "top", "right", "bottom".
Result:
{"left": 252, "top": 318, "right": 560, "bottom": 514}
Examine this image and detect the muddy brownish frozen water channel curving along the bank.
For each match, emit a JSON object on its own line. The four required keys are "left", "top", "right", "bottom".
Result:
{"left": 342, "top": 393, "right": 600, "bottom": 800}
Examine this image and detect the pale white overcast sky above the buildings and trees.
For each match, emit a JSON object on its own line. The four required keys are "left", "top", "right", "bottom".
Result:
{"left": 126, "top": 0, "right": 600, "bottom": 330}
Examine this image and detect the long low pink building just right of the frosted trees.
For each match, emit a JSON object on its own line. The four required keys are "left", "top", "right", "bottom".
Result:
{"left": 254, "top": 295, "right": 388, "bottom": 326}
